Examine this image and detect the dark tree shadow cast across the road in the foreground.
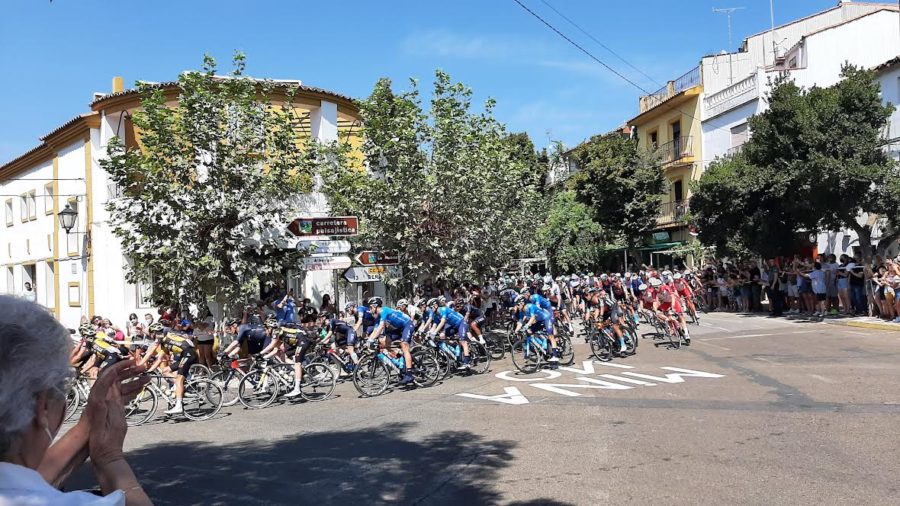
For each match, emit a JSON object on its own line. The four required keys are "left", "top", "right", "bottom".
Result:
{"left": 67, "top": 423, "right": 562, "bottom": 505}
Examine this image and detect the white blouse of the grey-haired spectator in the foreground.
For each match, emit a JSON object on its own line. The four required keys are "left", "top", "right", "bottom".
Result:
{"left": 0, "top": 462, "right": 125, "bottom": 506}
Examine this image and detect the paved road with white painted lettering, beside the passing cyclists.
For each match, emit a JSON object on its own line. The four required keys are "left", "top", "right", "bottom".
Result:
{"left": 65, "top": 314, "right": 900, "bottom": 505}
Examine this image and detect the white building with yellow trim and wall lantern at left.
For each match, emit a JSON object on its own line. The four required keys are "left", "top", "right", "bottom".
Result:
{"left": 0, "top": 78, "right": 359, "bottom": 328}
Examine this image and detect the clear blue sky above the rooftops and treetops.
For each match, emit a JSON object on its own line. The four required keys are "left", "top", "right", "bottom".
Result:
{"left": 0, "top": 0, "right": 837, "bottom": 163}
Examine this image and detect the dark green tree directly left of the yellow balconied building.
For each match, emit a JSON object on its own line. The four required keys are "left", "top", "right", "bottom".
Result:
{"left": 570, "top": 133, "right": 666, "bottom": 256}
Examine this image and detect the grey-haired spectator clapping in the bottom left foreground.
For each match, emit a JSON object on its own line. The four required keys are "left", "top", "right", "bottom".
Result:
{"left": 0, "top": 295, "right": 152, "bottom": 506}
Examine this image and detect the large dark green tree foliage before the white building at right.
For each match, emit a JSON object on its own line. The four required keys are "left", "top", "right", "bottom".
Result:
{"left": 691, "top": 65, "right": 900, "bottom": 258}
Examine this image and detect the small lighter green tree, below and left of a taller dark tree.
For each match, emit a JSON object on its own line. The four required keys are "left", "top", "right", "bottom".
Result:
{"left": 538, "top": 190, "right": 604, "bottom": 272}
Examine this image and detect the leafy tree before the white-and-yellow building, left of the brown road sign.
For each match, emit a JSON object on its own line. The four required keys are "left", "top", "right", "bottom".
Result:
{"left": 101, "top": 54, "right": 328, "bottom": 310}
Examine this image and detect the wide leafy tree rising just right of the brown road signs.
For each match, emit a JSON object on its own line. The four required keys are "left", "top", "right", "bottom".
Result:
{"left": 323, "top": 71, "right": 542, "bottom": 280}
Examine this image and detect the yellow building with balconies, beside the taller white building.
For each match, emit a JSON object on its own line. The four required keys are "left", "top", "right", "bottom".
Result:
{"left": 628, "top": 66, "right": 703, "bottom": 263}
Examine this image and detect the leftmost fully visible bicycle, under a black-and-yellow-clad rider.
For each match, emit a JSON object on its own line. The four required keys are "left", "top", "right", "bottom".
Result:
{"left": 125, "top": 373, "right": 223, "bottom": 427}
